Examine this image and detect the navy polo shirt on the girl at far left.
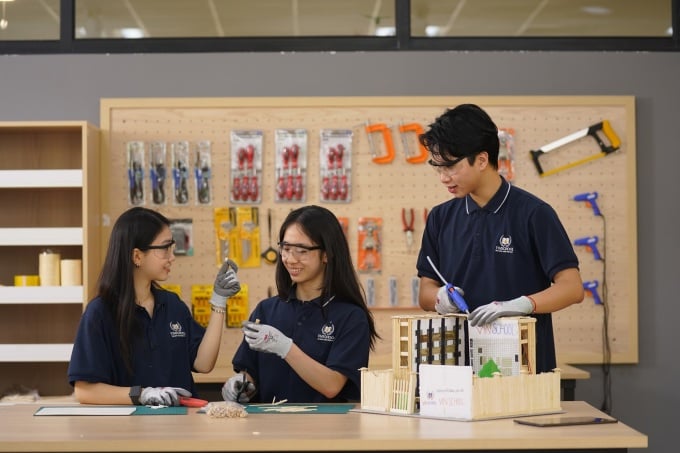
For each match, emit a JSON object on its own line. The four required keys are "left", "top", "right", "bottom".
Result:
{"left": 68, "top": 288, "right": 205, "bottom": 395}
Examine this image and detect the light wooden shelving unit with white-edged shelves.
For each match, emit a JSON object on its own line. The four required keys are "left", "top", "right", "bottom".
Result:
{"left": 0, "top": 121, "right": 101, "bottom": 394}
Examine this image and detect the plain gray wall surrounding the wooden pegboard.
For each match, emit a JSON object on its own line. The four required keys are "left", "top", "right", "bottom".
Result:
{"left": 0, "top": 52, "right": 680, "bottom": 452}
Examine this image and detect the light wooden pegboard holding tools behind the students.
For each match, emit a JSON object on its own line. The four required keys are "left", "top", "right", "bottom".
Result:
{"left": 101, "top": 96, "right": 638, "bottom": 367}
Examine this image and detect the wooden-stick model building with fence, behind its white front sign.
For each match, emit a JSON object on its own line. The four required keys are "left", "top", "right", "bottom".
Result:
{"left": 361, "top": 314, "right": 561, "bottom": 420}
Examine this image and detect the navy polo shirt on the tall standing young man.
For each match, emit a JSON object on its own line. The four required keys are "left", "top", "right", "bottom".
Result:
{"left": 416, "top": 179, "right": 578, "bottom": 372}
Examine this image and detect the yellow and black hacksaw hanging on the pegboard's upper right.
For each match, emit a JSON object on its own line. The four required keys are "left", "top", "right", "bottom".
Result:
{"left": 529, "top": 120, "right": 621, "bottom": 177}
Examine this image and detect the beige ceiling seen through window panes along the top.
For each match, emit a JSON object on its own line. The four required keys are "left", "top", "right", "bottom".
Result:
{"left": 0, "top": 0, "right": 672, "bottom": 40}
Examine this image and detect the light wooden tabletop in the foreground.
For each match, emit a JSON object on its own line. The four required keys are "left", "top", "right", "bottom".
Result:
{"left": 0, "top": 400, "right": 647, "bottom": 452}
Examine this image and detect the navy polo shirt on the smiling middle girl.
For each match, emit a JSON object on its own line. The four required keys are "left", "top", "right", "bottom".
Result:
{"left": 232, "top": 296, "right": 371, "bottom": 403}
